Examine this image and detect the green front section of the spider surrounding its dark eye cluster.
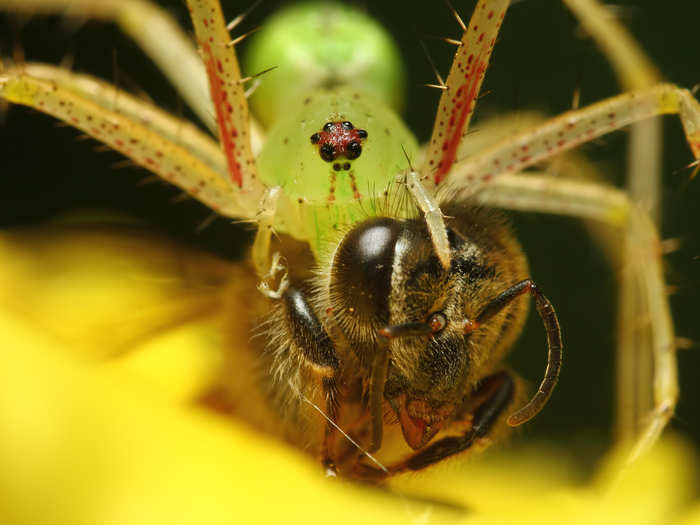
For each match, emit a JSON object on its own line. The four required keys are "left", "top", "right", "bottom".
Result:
{"left": 257, "top": 89, "right": 417, "bottom": 253}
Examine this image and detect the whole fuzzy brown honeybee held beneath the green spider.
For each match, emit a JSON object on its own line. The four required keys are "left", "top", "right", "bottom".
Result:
{"left": 209, "top": 199, "right": 561, "bottom": 479}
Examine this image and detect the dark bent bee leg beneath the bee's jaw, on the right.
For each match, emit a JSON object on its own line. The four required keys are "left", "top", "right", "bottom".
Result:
{"left": 359, "top": 372, "right": 515, "bottom": 480}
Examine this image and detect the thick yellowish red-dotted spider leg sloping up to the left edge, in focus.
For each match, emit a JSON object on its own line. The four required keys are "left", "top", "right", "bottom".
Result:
{"left": 0, "top": 64, "right": 255, "bottom": 217}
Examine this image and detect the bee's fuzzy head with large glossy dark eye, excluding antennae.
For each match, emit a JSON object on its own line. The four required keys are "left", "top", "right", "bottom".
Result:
{"left": 329, "top": 209, "right": 527, "bottom": 449}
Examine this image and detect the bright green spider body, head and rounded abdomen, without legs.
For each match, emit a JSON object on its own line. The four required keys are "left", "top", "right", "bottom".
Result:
{"left": 248, "top": 3, "right": 418, "bottom": 254}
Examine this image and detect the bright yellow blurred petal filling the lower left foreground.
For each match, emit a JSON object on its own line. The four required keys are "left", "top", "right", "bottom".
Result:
{"left": 0, "top": 316, "right": 464, "bottom": 525}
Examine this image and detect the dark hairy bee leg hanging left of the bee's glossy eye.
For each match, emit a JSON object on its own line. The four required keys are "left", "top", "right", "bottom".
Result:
{"left": 282, "top": 286, "right": 340, "bottom": 475}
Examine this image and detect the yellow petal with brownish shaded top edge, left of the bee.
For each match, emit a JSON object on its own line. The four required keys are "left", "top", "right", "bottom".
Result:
{"left": 0, "top": 225, "right": 235, "bottom": 399}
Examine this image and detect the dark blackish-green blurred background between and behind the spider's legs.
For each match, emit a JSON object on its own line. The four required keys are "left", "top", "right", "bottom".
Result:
{"left": 0, "top": 0, "right": 700, "bottom": 472}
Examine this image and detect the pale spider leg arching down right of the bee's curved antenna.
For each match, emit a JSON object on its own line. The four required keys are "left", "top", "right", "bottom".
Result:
{"left": 475, "top": 174, "right": 678, "bottom": 461}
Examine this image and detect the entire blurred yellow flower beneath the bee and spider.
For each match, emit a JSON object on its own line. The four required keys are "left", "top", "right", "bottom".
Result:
{"left": 0, "top": 223, "right": 700, "bottom": 525}
